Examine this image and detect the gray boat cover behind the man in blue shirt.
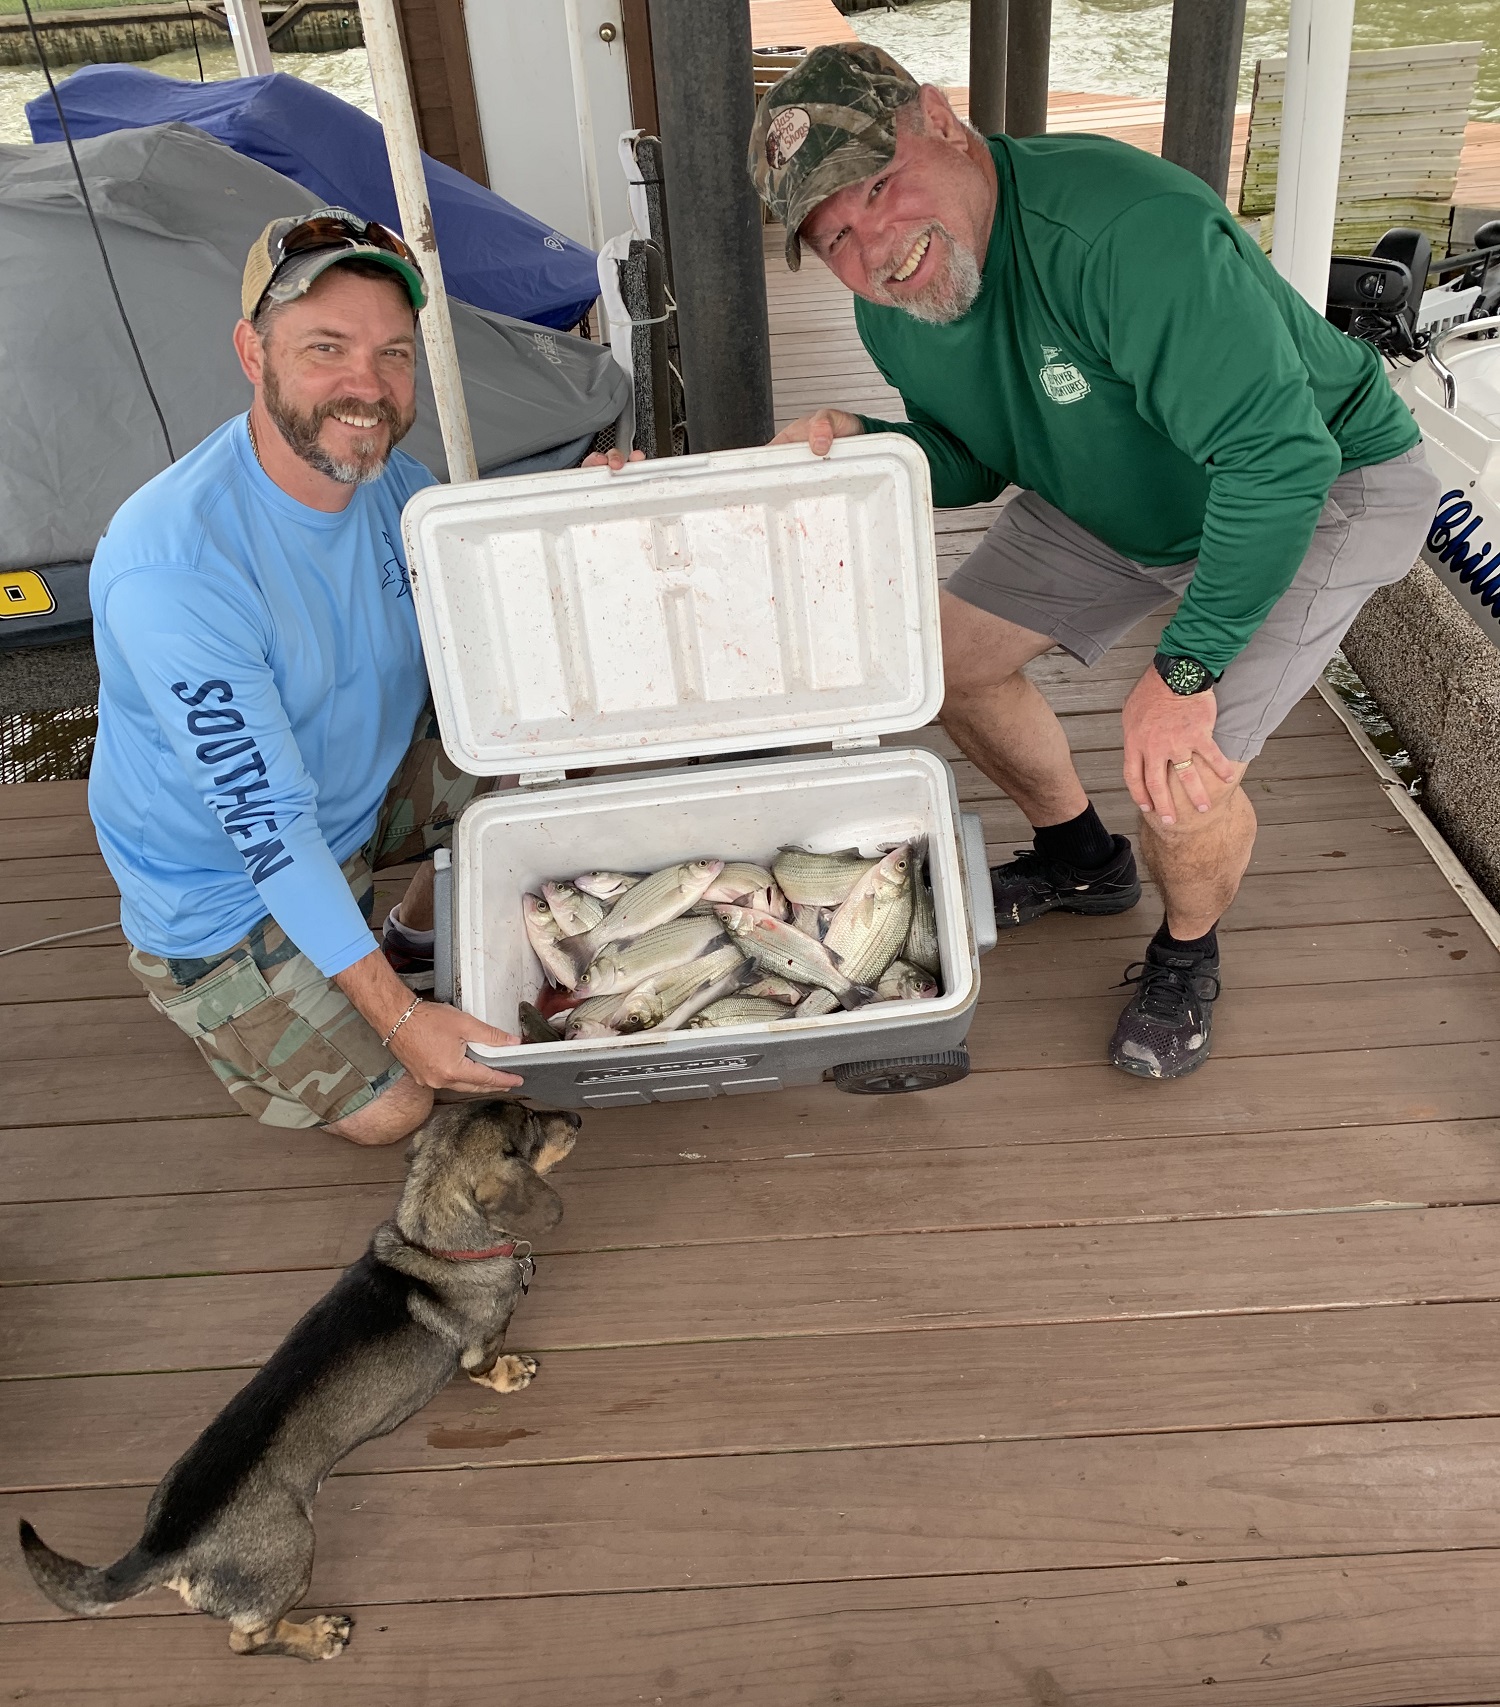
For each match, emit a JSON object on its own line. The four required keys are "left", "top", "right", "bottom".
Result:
{"left": 0, "top": 125, "right": 630, "bottom": 568}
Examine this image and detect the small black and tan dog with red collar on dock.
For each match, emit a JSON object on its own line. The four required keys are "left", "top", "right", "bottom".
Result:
{"left": 20, "top": 1101, "right": 582, "bottom": 1659}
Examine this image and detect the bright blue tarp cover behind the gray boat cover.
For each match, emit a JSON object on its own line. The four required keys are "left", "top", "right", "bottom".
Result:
{"left": 26, "top": 65, "right": 599, "bottom": 328}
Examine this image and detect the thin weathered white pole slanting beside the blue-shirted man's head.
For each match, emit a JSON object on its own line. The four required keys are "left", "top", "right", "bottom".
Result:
{"left": 360, "top": 0, "right": 480, "bottom": 481}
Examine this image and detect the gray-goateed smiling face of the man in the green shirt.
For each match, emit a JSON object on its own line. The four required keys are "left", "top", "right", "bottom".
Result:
{"left": 800, "top": 85, "right": 995, "bottom": 324}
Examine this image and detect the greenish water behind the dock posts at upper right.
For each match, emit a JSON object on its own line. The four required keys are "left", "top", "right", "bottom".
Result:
{"left": 850, "top": 0, "right": 1500, "bottom": 121}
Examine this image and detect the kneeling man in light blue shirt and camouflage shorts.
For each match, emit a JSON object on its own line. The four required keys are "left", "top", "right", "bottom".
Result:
{"left": 89, "top": 208, "right": 520, "bottom": 1144}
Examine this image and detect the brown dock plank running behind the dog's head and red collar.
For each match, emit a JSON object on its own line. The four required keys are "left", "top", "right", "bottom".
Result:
{"left": 0, "top": 1120, "right": 1500, "bottom": 1285}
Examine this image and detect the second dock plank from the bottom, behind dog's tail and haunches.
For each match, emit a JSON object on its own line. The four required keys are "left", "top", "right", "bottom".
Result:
{"left": 11, "top": 1417, "right": 1500, "bottom": 1623}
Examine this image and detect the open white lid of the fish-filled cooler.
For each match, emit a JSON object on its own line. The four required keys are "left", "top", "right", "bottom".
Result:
{"left": 401, "top": 434, "right": 942, "bottom": 777}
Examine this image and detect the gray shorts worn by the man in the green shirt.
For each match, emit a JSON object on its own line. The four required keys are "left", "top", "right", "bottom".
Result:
{"left": 947, "top": 446, "right": 1439, "bottom": 761}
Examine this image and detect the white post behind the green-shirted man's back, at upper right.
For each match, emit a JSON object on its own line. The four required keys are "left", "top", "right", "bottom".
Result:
{"left": 1271, "top": 0, "right": 1355, "bottom": 314}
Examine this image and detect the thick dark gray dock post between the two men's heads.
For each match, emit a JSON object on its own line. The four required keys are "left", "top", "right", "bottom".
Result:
{"left": 650, "top": 0, "right": 782, "bottom": 451}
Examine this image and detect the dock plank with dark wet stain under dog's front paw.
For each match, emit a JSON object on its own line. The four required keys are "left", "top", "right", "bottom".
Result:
{"left": 0, "top": 1304, "right": 1500, "bottom": 1492}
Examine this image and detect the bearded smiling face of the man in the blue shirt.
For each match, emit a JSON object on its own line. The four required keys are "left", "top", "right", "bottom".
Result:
{"left": 252, "top": 265, "right": 416, "bottom": 485}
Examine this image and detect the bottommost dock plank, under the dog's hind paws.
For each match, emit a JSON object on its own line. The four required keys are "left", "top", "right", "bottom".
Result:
{"left": 7, "top": 1556, "right": 1500, "bottom": 1707}
